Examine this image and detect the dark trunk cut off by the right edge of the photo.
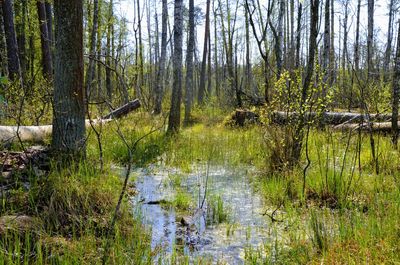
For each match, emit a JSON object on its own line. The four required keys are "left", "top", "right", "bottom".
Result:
{"left": 392, "top": 21, "right": 400, "bottom": 144}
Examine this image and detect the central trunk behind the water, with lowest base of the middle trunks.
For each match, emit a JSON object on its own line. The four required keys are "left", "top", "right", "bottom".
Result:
{"left": 168, "top": 0, "right": 183, "bottom": 133}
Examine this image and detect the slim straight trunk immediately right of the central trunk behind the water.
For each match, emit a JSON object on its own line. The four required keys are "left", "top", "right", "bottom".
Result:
{"left": 184, "top": 0, "right": 195, "bottom": 124}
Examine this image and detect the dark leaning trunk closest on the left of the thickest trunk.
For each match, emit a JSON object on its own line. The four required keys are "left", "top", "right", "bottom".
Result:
{"left": 36, "top": 0, "right": 53, "bottom": 80}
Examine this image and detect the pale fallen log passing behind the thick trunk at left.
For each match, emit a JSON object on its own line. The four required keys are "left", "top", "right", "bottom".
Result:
{"left": 0, "top": 99, "right": 140, "bottom": 142}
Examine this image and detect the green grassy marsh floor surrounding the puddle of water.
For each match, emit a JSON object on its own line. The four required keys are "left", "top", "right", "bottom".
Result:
{"left": 0, "top": 104, "right": 400, "bottom": 264}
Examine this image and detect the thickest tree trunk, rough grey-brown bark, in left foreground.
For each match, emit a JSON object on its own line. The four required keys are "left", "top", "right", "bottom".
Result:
{"left": 52, "top": 0, "right": 86, "bottom": 158}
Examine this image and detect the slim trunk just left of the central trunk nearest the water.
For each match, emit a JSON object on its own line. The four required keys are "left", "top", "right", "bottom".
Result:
{"left": 154, "top": 0, "right": 168, "bottom": 114}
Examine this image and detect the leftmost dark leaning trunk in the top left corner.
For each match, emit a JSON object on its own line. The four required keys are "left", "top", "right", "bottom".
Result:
{"left": 2, "top": 0, "right": 22, "bottom": 85}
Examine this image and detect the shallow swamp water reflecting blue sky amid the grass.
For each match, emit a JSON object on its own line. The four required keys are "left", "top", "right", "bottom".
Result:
{"left": 133, "top": 166, "right": 290, "bottom": 264}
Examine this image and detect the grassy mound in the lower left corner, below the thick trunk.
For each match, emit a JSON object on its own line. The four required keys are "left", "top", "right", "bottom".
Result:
{"left": 0, "top": 164, "right": 151, "bottom": 264}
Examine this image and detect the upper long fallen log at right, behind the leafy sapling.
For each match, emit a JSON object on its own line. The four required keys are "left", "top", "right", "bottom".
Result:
{"left": 271, "top": 111, "right": 392, "bottom": 125}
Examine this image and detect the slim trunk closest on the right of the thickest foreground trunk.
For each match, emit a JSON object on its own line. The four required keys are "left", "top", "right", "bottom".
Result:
{"left": 85, "top": 0, "right": 99, "bottom": 102}
